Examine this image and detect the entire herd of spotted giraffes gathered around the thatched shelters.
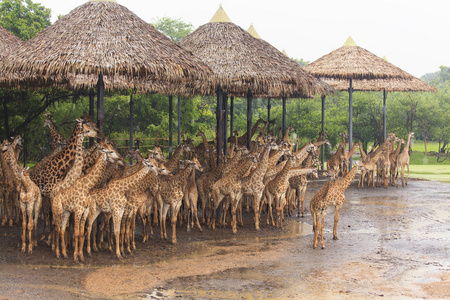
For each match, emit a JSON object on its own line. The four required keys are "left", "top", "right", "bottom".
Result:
{"left": 0, "top": 114, "right": 414, "bottom": 262}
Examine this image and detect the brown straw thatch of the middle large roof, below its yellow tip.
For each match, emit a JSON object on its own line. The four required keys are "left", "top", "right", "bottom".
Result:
{"left": 179, "top": 22, "right": 327, "bottom": 98}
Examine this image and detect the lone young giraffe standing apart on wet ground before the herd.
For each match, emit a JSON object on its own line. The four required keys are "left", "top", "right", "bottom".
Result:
{"left": 311, "top": 162, "right": 360, "bottom": 249}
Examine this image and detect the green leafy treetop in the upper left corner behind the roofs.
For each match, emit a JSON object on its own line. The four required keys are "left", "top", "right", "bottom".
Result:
{"left": 0, "top": 0, "right": 51, "bottom": 41}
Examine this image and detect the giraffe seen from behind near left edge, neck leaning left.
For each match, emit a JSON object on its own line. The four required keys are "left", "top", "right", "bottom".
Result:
{"left": 2, "top": 137, "right": 42, "bottom": 254}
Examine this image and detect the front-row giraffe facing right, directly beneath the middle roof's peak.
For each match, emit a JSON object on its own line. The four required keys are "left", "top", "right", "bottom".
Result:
{"left": 210, "top": 155, "right": 256, "bottom": 234}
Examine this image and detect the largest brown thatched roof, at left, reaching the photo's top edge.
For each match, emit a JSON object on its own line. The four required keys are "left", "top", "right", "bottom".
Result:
{"left": 0, "top": 1, "right": 211, "bottom": 91}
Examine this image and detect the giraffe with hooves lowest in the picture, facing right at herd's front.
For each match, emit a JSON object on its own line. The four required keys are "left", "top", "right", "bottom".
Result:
{"left": 52, "top": 147, "right": 115, "bottom": 261}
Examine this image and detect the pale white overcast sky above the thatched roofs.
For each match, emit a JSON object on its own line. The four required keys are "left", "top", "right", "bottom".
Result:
{"left": 33, "top": 0, "right": 450, "bottom": 77}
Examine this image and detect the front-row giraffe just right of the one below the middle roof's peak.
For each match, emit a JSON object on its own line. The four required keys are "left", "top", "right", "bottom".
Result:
{"left": 241, "top": 142, "right": 278, "bottom": 230}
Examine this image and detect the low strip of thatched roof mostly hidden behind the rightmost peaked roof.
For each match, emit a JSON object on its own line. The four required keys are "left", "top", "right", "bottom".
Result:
{"left": 322, "top": 77, "right": 437, "bottom": 92}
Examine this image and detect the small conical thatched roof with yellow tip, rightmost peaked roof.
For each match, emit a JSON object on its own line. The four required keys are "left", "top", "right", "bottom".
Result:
{"left": 305, "top": 37, "right": 412, "bottom": 79}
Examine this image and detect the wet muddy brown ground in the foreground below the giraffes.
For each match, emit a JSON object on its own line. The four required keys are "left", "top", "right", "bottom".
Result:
{"left": 0, "top": 180, "right": 450, "bottom": 299}
